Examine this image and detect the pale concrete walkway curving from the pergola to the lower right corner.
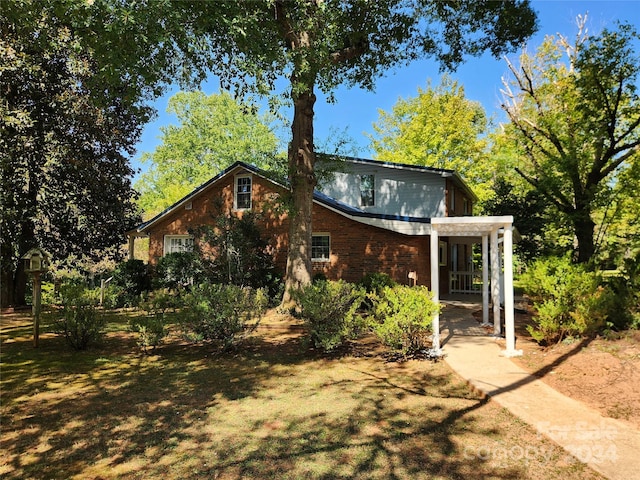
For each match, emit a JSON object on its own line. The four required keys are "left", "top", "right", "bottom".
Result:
{"left": 441, "top": 301, "right": 640, "bottom": 480}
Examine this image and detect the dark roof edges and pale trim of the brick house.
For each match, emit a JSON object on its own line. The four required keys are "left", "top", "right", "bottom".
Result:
{"left": 136, "top": 156, "right": 477, "bottom": 234}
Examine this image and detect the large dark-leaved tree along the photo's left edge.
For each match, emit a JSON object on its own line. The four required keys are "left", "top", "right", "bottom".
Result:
{"left": 0, "top": 1, "right": 144, "bottom": 306}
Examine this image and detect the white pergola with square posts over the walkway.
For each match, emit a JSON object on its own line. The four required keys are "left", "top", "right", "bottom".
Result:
{"left": 430, "top": 216, "right": 522, "bottom": 357}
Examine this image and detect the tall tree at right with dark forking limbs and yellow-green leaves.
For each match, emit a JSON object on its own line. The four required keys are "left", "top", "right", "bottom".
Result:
{"left": 503, "top": 17, "right": 640, "bottom": 262}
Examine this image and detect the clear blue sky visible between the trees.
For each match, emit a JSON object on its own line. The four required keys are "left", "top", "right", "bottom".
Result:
{"left": 132, "top": 0, "right": 640, "bottom": 181}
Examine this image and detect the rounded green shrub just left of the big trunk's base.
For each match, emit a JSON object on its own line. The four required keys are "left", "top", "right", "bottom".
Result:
{"left": 181, "top": 284, "right": 267, "bottom": 350}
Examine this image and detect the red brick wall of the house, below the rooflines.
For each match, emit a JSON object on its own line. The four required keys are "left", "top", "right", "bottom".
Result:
{"left": 148, "top": 167, "right": 450, "bottom": 293}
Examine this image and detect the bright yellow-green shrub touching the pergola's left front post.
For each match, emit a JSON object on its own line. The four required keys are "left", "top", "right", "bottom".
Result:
{"left": 369, "top": 285, "right": 438, "bottom": 356}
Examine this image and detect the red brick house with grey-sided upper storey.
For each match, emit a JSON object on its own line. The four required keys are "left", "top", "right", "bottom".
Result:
{"left": 132, "top": 158, "right": 477, "bottom": 293}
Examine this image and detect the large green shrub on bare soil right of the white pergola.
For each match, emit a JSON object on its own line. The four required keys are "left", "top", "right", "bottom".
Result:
{"left": 522, "top": 257, "right": 615, "bottom": 345}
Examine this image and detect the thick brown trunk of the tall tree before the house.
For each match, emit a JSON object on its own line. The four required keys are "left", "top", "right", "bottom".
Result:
{"left": 283, "top": 87, "right": 316, "bottom": 303}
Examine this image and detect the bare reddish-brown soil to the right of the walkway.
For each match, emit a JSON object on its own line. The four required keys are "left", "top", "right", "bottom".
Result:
{"left": 474, "top": 312, "right": 640, "bottom": 428}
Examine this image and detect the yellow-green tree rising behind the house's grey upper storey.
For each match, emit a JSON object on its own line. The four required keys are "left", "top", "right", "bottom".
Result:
{"left": 369, "top": 76, "right": 493, "bottom": 199}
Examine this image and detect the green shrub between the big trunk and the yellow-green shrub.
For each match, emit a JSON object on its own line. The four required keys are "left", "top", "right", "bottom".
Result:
{"left": 292, "top": 280, "right": 365, "bottom": 352}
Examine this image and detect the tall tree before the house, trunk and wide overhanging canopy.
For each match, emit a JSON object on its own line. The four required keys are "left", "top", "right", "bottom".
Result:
{"left": 77, "top": 0, "right": 535, "bottom": 300}
